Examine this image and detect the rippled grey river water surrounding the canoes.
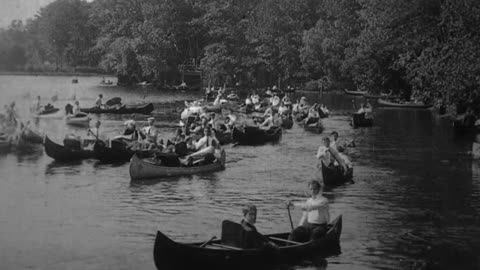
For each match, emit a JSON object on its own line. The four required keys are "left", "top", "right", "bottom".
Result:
{"left": 0, "top": 76, "right": 480, "bottom": 270}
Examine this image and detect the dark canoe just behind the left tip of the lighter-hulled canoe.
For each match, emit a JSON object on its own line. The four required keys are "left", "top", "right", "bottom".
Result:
{"left": 93, "top": 140, "right": 150, "bottom": 163}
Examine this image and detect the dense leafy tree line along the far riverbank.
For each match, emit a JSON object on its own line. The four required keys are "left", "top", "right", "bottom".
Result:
{"left": 0, "top": 0, "right": 480, "bottom": 107}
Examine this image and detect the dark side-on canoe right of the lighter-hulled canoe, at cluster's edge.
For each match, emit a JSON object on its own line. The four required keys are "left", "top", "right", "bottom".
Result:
{"left": 232, "top": 127, "right": 282, "bottom": 145}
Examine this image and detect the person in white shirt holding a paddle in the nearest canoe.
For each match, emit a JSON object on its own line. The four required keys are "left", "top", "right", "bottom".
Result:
{"left": 287, "top": 180, "right": 330, "bottom": 243}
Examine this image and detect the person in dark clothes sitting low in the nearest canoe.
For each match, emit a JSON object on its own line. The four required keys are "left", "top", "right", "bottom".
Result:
{"left": 240, "top": 205, "right": 278, "bottom": 248}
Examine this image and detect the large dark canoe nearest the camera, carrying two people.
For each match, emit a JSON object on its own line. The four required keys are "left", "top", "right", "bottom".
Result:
{"left": 153, "top": 216, "right": 342, "bottom": 270}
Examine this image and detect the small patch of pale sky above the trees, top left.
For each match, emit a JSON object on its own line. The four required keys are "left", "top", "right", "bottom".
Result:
{"left": 0, "top": 0, "right": 91, "bottom": 27}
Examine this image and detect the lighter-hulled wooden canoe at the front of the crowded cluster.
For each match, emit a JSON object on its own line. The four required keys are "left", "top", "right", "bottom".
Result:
{"left": 129, "top": 150, "right": 225, "bottom": 180}
